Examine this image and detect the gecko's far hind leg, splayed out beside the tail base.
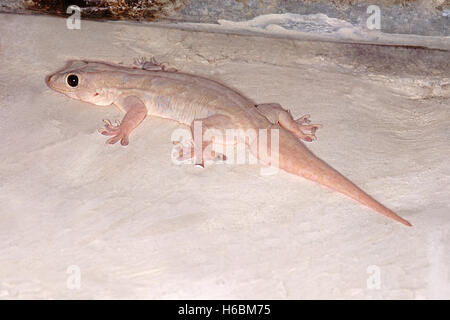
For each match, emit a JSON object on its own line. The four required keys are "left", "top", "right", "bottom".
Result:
{"left": 256, "top": 103, "right": 322, "bottom": 142}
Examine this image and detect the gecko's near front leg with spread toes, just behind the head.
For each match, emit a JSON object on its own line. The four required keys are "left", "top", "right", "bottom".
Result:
{"left": 99, "top": 96, "right": 147, "bottom": 146}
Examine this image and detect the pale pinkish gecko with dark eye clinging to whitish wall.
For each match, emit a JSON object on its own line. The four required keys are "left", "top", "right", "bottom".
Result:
{"left": 46, "top": 58, "right": 412, "bottom": 226}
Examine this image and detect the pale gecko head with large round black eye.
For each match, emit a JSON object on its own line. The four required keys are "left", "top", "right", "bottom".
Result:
{"left": 46, "top": 60, "right": 115, "bottom": 106}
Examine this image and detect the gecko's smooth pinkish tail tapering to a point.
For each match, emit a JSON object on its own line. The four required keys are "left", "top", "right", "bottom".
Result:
{"left": 279, "top": 129, "right": 412, "bottom": 227}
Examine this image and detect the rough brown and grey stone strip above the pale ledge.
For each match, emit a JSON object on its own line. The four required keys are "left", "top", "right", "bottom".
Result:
{"left": 0, "top": 0, "right": 450, "bottom": 36}
